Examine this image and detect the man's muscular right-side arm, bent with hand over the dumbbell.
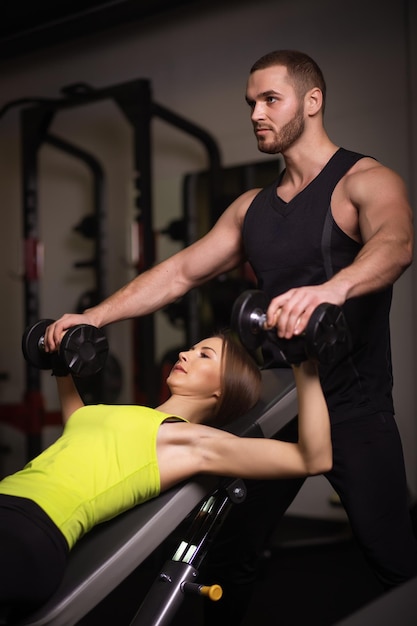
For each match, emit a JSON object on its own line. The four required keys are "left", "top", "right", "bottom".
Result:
{"left": 268, "top": 164, "right": 413, "bottom": 338}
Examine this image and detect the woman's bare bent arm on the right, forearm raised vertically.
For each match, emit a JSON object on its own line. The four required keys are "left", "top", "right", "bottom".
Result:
{"left": 158, "top": 361, "right": 332, "bottom": 489}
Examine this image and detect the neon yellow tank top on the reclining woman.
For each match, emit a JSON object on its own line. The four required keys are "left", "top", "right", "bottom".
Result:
{"left": 0, "top": 405, "right": 184, "bottom": 548}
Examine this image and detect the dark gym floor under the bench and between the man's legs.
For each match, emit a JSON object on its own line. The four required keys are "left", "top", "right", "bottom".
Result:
{"left": 80, "top": 510, "right": 410, "bottom": 626}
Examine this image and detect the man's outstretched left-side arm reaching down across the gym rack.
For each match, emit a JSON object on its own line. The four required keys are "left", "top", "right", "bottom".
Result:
{"left": 45, "top": 190, "right": 259, "bottom": 351}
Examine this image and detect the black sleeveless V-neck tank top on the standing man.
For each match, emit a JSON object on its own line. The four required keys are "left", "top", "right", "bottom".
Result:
{"left": 243, "top": 148, "right": 393, "bottom": 422}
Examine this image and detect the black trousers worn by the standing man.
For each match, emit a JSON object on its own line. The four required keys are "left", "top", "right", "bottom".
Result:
{"left": 205, "top": 413, "right": 417, "bottom": 626}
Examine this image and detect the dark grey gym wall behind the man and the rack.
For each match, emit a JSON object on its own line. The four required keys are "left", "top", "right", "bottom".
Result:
{"left": 0, "top": 0, "right": 417, "bottom": 510}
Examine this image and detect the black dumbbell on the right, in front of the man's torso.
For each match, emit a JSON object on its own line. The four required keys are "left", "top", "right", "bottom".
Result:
{"left": 231, "top": 289, "right": 350, "bottom": 365}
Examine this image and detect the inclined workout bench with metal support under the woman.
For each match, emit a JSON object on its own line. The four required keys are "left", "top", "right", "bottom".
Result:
{"left": 8, "top": 369, "right": 297, "bottom": 626}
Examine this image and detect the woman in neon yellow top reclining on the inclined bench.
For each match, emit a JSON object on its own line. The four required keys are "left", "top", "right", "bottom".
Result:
{"left": 0, "top": 335, "right": 332, "bottom": 612}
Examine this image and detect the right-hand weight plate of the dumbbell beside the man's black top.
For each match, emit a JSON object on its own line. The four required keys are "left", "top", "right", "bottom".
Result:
{"left": 304, "top": 303, "right": 350, "bottom": 365}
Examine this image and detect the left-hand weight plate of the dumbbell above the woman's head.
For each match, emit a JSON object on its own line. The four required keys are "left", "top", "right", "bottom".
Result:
{"left": 231, "top": 289, "right": 269, "bottom": 350}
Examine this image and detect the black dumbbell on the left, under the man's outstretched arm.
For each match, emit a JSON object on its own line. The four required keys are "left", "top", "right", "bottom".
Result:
{"left": 22, "top": 319, "right": 109, "bottom": 378}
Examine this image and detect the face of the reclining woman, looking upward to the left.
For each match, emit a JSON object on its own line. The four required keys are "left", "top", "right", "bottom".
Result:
{"left": 167, "top": 337, "right": 223, "bottom": 398}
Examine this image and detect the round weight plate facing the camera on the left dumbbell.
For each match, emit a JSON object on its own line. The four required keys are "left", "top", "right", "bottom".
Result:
{"left": 59, "top": 324, "right": 109, "bottom": 377}
